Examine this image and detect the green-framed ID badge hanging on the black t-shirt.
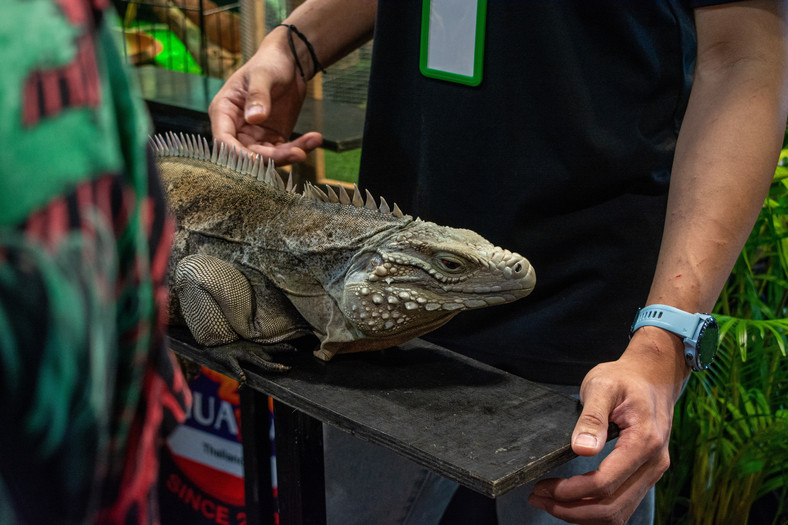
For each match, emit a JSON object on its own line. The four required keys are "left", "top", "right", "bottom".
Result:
{"left": 419, "top": 0, "right": 487, "bottom": 86}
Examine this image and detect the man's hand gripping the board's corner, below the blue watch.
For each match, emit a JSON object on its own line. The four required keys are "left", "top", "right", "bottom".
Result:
{"left": 529, "top": 326, "right": 689, "bottom": 524}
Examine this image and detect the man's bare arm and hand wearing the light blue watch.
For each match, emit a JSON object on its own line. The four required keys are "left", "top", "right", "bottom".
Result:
{"left": 530, "top": 0, "right": 788, "bottom": 523}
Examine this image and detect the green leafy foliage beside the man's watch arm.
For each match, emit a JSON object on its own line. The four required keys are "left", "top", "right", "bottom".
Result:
{"left": 657, "top": 149, "right": 788, "bottom": 525}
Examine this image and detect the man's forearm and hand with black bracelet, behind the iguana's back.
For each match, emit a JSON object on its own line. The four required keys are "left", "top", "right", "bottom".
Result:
{"left": 208, "top": 0, "right": 377, "bottom": 164}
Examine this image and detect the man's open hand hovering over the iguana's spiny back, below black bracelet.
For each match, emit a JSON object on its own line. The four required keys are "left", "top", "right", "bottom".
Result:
{"left": 208, "top": 27, "right": 323, "bottom": 165}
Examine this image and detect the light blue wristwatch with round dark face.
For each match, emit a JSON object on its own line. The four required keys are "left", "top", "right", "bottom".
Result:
{"left": 629, "top": 304, "right": 720, "bottom": 372}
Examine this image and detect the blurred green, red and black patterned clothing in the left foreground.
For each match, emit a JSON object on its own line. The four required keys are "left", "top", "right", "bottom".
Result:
{"left": 0, "top": 0, "right": 190, "bottom": 525}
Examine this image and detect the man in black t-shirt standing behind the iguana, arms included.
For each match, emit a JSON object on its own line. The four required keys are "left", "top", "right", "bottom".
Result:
{"left": 210, "top": 0, "right": 788, "bottom": 522}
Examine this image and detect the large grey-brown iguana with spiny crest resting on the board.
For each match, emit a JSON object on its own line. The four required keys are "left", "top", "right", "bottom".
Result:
{"left": 151, "top": 134, "right": 536, "bottom": 370}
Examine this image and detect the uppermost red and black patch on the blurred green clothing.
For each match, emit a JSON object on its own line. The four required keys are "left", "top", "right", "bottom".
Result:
{"left": 22, "top": 35, "right": 101, "bottom": 126}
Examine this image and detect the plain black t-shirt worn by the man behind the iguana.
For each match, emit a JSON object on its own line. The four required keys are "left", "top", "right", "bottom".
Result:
{"left": 360, "top": 0, "right": 716, "bottom": 384}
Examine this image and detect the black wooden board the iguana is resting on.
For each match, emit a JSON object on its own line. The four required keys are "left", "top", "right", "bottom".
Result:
{"left": 170, "top": 330, "right": 580, "bottom": 497}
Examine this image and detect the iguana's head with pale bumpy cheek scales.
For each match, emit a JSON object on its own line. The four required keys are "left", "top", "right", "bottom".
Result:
{"left": 340, "top": 219, "right": 536, "bottom": 339}
